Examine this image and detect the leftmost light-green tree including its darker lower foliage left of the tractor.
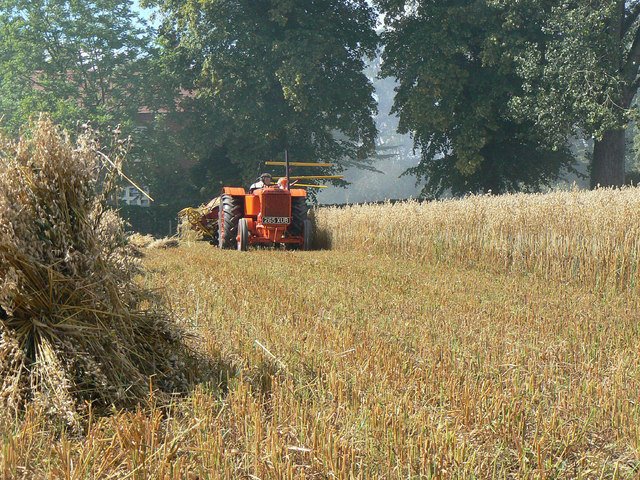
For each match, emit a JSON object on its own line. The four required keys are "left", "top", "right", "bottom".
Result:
{"left": 0, "top": 0, "right": 198, "bottom": 203}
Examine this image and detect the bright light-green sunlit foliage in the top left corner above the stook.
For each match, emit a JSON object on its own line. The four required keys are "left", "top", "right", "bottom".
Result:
{"left": 0, "top": 0, "right": 150, "bottom": 132}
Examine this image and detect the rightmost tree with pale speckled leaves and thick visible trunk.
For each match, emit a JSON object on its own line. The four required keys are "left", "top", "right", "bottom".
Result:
{"left": 494, "top": 0, "right": 640, "bottom": 186}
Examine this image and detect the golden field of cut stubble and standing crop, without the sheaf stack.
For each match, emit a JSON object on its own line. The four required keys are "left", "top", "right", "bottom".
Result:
{"left": 0, "top": 189, "right": 640, "bottom": 479}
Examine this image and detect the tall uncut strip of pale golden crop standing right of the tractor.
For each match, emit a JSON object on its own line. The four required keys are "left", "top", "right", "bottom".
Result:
{"left": 315, "top": 188, "right": 640, "bottom": 290}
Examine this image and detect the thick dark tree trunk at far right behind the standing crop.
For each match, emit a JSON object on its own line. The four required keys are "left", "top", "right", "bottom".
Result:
{"left": 591, "top": 129, "right": 624, "bottom": 188}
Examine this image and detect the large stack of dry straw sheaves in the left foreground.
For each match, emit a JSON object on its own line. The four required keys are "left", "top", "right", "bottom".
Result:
{"left": 0, "top": 119, "right": 195, "bottom": 426}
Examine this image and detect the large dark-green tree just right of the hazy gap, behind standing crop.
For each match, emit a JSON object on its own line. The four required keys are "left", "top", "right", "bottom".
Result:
{"left": 376, "top": 0, "right": 572, "bottom": 196}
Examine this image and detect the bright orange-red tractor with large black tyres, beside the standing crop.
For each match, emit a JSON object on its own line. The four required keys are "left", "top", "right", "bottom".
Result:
{"left": 218, "top": 183, "right": 313, "bottom": 251}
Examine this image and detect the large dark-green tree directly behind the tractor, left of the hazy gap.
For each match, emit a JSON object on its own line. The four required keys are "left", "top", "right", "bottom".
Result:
{"left": 148, "top": 0, "right": 378, "bottom": 184}
